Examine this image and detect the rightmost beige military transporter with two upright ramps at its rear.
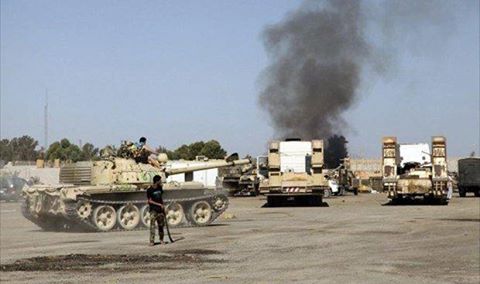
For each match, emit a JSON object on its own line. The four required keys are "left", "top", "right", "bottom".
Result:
{"left": 382, "top": 136, "right": 449, "bottom": 204}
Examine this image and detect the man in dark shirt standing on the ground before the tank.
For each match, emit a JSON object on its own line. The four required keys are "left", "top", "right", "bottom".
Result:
{"left": 147, "top": 175, "right": 165, "bottom": 246}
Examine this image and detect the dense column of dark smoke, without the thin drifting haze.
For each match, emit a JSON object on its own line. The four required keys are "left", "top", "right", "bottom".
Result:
{"left": 260, "top": 0, "right": 369, "bottom": 139}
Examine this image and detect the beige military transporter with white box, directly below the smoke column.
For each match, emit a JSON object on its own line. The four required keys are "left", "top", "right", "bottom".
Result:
{"left": 262, "top": 139, "right": 328, "bottom": 206}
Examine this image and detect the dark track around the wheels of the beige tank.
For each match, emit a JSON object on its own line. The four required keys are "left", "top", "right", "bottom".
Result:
{"left": 22, "top": 193, "right": 228, "bottom": 232}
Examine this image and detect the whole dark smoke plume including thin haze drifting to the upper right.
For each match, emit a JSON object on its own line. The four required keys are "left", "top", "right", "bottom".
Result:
{"left": 259, "top": 0, "right": 455, "bottom": 139}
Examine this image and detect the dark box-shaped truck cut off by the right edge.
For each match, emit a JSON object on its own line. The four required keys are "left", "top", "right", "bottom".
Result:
{"left": 458, "top": 157, "right": 480, "bottom": 197}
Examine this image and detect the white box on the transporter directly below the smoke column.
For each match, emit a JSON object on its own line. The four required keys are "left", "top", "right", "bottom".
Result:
{"left": 279, "top": 141, "right": 312, "bottom": 173}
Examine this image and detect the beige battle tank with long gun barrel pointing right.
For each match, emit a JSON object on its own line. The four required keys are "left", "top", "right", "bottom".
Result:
{"left": 22, "top": 154, "right": 250, "bottom": 231}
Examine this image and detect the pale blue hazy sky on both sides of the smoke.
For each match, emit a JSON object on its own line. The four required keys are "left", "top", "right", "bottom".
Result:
{"left": 0, "top": 0, "right": 480, "bottom": 157}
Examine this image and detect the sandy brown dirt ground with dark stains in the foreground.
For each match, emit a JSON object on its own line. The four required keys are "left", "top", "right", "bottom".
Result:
{"left": 0, "top": 194, "right": 480, "bottom": 283}
